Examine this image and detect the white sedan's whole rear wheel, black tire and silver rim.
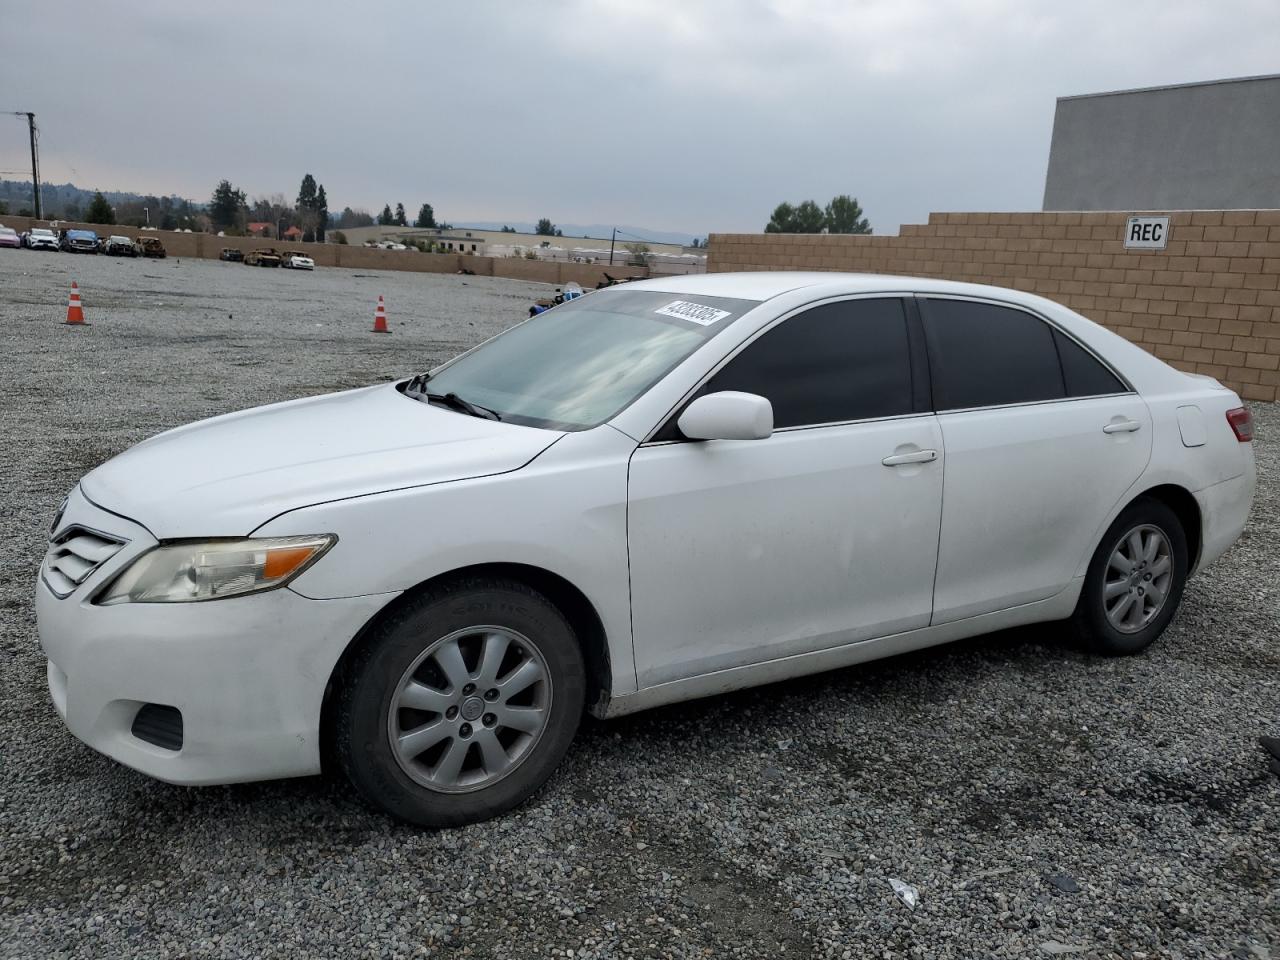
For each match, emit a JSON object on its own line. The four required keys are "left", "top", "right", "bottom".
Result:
{"left": 1073, "top": 497, "right": 1190, "bottom": 657}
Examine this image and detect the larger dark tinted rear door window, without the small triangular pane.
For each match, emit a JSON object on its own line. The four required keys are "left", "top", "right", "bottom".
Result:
{"left": 924, "top": 300, "right": 1066, "bottom": 410}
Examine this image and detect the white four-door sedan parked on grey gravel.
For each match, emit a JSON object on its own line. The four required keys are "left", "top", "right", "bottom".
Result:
{"left": 36, "top": 273, "right": 1254, "bottom": 826}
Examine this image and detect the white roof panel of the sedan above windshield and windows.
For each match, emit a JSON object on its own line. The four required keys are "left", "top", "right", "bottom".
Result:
{"left": 627, "top": 270, "right": 1059, "bottom": 305}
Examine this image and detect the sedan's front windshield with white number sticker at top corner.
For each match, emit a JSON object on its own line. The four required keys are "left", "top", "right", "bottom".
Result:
{"left": 428, "top": 291, "right": 758, "bottom": 430}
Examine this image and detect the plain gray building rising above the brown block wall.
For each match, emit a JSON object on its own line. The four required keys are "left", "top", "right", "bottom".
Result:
{"left": 1043, "top": 74, "right": 1280, "bottom": 210}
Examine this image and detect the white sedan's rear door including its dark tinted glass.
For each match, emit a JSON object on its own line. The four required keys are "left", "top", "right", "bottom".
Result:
{"left": 918, "top": 297, "right": 1152, "bottom": 623}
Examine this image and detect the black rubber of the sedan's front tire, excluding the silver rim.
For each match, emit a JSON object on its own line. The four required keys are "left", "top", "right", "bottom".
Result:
{"left": 335, "top": 582, "right": 586, "bottom": 827}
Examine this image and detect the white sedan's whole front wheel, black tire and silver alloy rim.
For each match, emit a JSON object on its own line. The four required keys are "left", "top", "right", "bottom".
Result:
{"left": 333, "top": 580, "right": 586, "bottom": 827}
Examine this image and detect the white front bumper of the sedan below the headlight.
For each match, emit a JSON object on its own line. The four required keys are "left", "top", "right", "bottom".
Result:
{"left": 36, "top": 489, "right": 396, "bottom": 785}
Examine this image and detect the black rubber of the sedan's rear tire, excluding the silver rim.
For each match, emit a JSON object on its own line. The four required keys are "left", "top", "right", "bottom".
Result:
{"left": 1076, "top": 498, "right": 1190, "bottom": 657}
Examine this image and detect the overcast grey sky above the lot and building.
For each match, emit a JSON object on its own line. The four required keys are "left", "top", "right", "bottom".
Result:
{"left": 0, "top": 0, "right": 1280, "bottom": 234}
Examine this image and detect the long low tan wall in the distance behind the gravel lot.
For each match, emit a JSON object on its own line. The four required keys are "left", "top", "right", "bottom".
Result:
{"left": 0, "top": 215, "right": 649, "bottom": 288}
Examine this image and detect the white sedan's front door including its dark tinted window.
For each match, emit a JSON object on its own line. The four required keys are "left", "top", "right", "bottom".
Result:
{"left": 627, "top": 298, "right": 943, "bottom": 687}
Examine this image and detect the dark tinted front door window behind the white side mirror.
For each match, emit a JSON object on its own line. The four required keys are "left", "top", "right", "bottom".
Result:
{"left": 700, "top": 300, "right": 911, "bottom": 428}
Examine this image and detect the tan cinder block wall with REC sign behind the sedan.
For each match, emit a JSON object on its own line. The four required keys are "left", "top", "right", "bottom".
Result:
{"left": 707, "top": 210, "right": 1280, "bottom": 401}
